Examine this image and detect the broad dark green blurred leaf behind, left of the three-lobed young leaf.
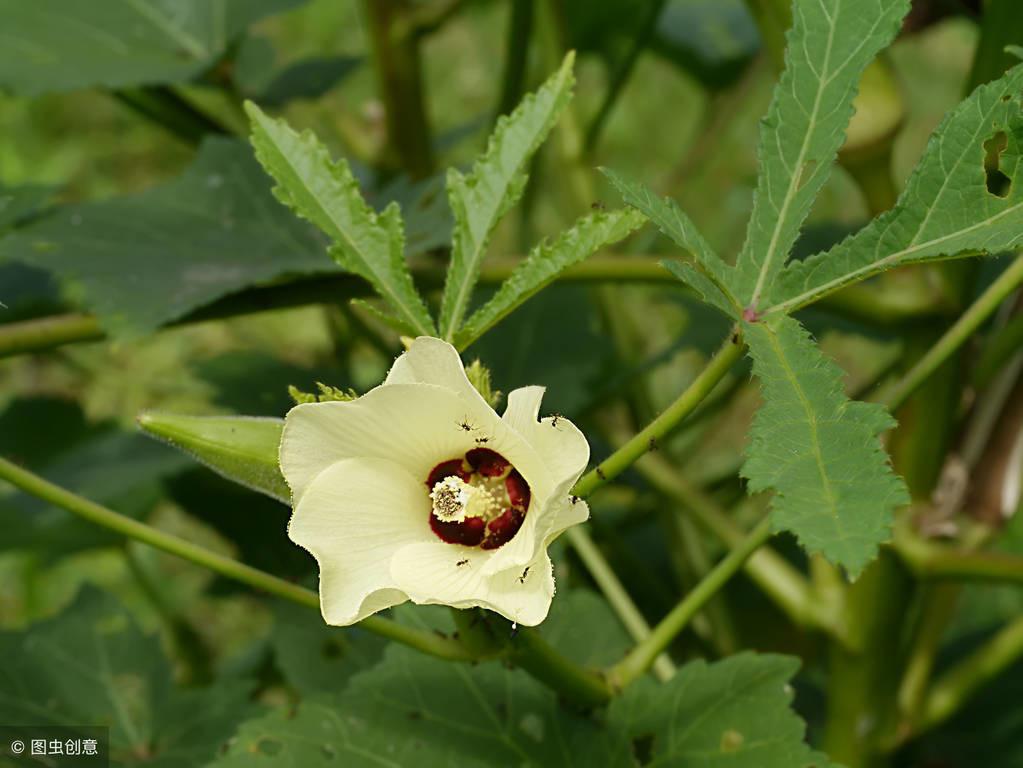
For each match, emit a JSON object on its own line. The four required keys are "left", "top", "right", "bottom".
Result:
{"left": 0, "top": 138, "right": 327, "bottom": 335}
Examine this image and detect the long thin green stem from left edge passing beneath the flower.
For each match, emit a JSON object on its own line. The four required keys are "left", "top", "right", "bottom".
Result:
{"left": 0, "top": 458, "right": 473, "bottom": 661}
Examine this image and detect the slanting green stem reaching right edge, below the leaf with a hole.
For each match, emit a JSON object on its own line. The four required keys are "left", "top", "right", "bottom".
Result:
{"left": 877, "top": 258, "right": 1023, "bottom": 410}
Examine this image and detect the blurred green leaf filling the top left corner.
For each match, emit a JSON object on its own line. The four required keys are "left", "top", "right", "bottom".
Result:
{"left": 0, "top": 0, "right": 304, "bottom": 96}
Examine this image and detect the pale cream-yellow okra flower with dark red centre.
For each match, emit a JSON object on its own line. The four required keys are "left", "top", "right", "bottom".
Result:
{"left": 280, "top": 336, "right": 589, "bottom": 626}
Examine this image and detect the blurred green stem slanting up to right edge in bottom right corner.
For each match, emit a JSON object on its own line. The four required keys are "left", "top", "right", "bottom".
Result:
{"left": 908, "top": 619, "right": 1023, "bottom": 736}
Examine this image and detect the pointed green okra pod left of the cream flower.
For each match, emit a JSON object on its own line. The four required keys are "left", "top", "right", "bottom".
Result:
{"left": 138, "top": 412, "right": 292, "bottom": 504}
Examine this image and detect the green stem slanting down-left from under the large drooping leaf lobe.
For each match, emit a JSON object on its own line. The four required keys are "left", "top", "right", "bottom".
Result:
{"left": 609, "top": 517, "right": 771, "bottom": 687}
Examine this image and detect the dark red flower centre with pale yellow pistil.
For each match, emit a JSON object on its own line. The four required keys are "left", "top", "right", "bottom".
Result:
{"left": 427, "top": 448, "right": 531, "bottom": 549}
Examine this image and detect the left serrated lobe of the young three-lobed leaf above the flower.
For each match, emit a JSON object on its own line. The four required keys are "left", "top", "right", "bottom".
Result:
{"left": 246, "top": 101, "right": 437, "bottom": 335}
